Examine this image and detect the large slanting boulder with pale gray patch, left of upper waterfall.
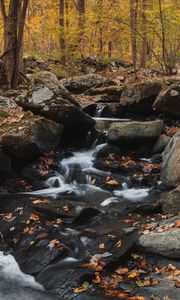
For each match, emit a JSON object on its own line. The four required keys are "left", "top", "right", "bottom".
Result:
{"left": 16, "top": 85, "right": 95, "bottom": 146}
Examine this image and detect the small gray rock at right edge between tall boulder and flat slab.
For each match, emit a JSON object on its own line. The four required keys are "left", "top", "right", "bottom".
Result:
{"left": 161, "top": 185, "right": 180, "bottom": 214}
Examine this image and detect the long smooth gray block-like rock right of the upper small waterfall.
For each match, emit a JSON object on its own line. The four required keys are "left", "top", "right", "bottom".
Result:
{"left": 108, "top": 120, "right": 163, "bottom": 144}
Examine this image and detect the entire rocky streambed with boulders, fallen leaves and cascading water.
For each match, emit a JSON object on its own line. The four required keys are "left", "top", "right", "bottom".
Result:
{"left": 0, "top": 72, "right": 180, "bottom": 300}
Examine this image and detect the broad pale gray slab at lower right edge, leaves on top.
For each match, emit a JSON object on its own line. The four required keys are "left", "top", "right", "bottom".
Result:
{"left": 138, "top": 217, "right": 180, "bottom": 258}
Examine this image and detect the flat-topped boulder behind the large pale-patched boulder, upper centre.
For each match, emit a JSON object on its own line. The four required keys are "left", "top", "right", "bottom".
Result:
{"left": 59, "top": 74, "right": 105, "bottom": 94}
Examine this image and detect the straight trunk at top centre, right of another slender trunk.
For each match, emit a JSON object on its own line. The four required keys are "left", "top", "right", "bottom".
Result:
{"left": 77, "top": 0, "right": 85, "bottom": 57}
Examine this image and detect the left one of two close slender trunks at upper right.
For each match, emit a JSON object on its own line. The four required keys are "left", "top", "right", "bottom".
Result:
{"left": 130, "top": 0, "right": 138, "bottom": 75}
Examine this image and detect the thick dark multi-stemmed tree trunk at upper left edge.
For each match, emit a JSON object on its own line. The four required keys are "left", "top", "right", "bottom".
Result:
{"left": 0, "top": 0, "right": 29, "bottom": 88}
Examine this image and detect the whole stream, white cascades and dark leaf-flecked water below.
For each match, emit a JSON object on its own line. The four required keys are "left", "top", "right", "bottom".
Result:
{"left": 0, "top": 111, "right": 177, "bottom": 300}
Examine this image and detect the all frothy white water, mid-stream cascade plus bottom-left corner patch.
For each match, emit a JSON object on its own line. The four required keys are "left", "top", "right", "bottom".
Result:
{"left": 0, "top": 116, "right": 153, "bottom": 300}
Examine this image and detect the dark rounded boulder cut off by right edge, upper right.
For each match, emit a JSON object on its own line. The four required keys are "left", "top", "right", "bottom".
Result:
{"left": 154, "top": 81, "right": 180, "bottom": 117}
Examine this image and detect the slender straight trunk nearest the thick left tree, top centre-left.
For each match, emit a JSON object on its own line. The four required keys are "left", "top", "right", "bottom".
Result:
{"left": 59, "top": 0, "right": 66, "bottom": 66}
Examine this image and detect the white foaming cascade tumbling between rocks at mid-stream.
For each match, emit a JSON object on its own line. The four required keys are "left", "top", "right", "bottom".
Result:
{"left": 24, "top": 144, "right": 150, "bottom": 206}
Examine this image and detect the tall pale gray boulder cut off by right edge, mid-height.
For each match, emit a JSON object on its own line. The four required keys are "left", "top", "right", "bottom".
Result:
{"left": 161, "top": 133, "right": 180, "bottom": 187}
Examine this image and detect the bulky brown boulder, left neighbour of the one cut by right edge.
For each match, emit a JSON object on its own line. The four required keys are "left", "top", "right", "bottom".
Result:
{"left": 120, "top": 82, "right": 162, "bottom": 114}
